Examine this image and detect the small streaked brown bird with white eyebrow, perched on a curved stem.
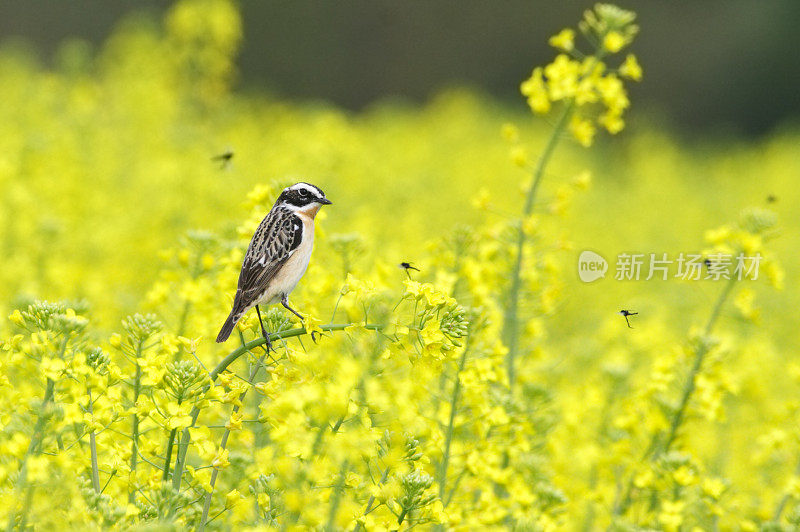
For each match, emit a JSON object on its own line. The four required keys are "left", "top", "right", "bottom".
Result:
{"left": 217, "top": 182, "right": 332, "bottom": 344}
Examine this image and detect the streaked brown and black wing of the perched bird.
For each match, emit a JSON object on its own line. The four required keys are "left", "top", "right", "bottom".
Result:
{"left": 234, "top": 207, "right": 303, "bottom": 307}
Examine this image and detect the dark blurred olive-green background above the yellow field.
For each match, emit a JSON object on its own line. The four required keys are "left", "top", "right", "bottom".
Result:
{"left": 0, "top": 0, "right": 800, "bottom": 135}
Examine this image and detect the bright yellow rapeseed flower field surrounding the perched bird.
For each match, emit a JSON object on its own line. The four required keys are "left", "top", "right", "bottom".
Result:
{"left": 0, "top": 0, "right": 800, "bottom": 531}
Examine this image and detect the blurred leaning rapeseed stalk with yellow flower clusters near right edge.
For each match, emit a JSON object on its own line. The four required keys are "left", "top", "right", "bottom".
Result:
{"left": 612, "top": 208, "right": 782, "bottom": 528}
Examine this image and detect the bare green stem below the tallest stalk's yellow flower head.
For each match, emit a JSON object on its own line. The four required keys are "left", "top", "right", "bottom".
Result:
{"left": 503, "top": 101, "right": 574, "bottom": 386}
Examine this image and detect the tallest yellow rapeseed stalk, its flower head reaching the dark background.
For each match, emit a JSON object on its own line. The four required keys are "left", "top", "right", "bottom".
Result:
{"left": 503, "top": 4, "right": 642, "bottom": 385}
